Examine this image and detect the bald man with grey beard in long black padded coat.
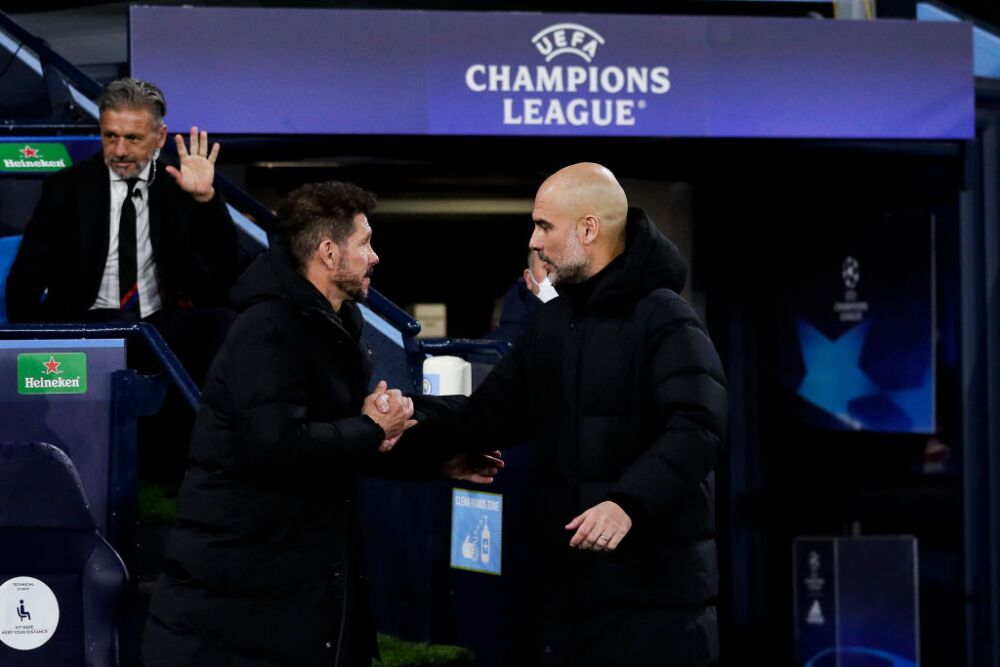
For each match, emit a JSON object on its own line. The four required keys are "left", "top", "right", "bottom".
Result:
{"left": 412, "top": 163, "right": 726, "bottom": 667}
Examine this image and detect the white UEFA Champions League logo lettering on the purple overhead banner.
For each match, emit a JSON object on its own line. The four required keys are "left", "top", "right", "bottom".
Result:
{"left": 465, "top": 23, "right": 670, "bottom": 127}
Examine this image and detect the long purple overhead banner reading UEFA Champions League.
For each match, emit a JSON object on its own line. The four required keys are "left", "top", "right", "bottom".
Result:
{"left": 129, "top": 6, "right": 975, "bottom": 139}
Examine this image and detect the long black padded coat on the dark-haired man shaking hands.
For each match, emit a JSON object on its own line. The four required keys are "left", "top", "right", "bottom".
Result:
{"left": 144, "top": 245, "right": 384, "bottom": 667}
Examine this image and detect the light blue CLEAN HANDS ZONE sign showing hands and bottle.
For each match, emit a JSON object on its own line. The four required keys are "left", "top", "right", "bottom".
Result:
{"left": 451, "top": 489, "right": 503, "bottom": 575}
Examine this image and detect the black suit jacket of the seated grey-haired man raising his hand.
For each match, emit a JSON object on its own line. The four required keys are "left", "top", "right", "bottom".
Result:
{"left": 7, "top": 152, "right": 241, "bottom": 322}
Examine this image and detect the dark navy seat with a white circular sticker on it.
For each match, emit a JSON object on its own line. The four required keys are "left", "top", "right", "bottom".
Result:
{"left": 0, "top": 442, "right": 128, "bottom": 667}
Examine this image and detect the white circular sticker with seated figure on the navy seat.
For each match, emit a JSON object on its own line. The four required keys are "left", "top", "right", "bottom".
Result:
{"left": 0, "top": 577, "right": 59, "bottom": 651}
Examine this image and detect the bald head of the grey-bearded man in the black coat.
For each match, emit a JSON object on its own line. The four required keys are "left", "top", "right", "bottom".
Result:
{"left": 530, "top": 162, "right": 628, "bottom": 283}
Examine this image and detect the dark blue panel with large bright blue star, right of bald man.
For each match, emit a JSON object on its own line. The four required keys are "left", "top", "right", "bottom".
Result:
{"left": 772, "top": 213, "right": 935, "bottom": 433}
